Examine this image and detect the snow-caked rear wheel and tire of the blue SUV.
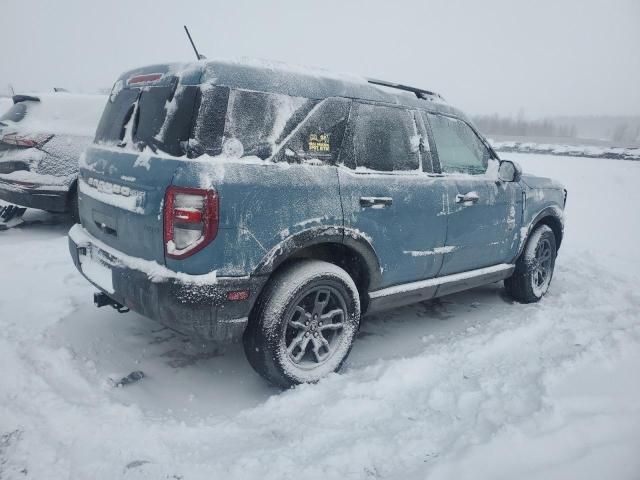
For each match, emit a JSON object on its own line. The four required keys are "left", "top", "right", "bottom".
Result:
{"left": 243, "top": 260, "right": 360, "bottom": 388}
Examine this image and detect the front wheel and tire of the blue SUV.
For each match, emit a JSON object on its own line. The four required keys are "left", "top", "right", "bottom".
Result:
{"left": 504, "top": 225, "right": 557, "bottom": 303}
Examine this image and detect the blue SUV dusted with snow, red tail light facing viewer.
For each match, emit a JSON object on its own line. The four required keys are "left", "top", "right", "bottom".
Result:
{"left": 69, "top": 61, "right": 566, "bottom": 386}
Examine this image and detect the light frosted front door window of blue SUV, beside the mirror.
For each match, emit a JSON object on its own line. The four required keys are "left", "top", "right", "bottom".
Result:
{"left": 427, "top": 114, "right": 490, "bottom": 175}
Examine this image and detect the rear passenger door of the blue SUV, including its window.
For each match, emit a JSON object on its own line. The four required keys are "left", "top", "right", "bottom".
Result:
{"left": 338, "top": 102, "right": 446, "bottom": 287}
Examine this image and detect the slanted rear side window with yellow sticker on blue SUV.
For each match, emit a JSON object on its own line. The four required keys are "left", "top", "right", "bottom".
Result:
{"left": 277, "top": 98, "right": 351, "bottom": 165}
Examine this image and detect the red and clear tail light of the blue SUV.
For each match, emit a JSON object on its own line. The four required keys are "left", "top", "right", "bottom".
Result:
{"left": 164, "top": 186, "right": 218, "bottom": 258}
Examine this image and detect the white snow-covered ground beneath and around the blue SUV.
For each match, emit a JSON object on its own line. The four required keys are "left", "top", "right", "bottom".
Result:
{"left": 0, "top": 153, "right": 640, "bottom": 480}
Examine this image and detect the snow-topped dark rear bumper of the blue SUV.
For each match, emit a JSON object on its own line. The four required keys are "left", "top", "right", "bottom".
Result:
{"left": 69, "top": 224, "right": 266, "bottom": 343}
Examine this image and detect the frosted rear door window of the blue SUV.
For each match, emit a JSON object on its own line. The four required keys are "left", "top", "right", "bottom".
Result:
{"left": 344, "top": 104, "right": 421, "bottom": 172}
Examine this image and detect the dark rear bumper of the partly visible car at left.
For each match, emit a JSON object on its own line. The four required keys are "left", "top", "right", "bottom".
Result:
{"left": 0, "top": 177, "right": 70, "bottom": 213}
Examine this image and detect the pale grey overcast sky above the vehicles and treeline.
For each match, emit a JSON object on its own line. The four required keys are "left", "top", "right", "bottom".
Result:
{"left": 0, "top": 0, "right": 640, "bottom": 117}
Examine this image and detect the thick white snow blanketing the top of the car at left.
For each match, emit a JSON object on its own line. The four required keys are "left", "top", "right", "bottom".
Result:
{"left": 5, "top": 92, "right": 107, "bottom": 137}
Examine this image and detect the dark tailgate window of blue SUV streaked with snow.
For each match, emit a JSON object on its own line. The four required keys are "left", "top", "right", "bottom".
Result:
{"left": 95, "top": 79, "right": 199, "bottom": 156}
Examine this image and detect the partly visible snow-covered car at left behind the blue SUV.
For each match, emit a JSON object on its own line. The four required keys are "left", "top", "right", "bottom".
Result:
{"left": 0, "top": 92, "right": 107, "bottom": 219}
